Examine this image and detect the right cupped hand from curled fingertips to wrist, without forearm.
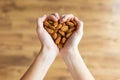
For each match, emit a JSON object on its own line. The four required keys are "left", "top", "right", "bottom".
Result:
{"left": 60, "top": 14, "right": 83, "bottom": 53}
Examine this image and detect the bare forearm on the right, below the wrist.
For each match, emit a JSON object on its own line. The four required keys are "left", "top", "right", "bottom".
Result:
{"left": 62, "top": 48, "right": 94, "bottom": 80}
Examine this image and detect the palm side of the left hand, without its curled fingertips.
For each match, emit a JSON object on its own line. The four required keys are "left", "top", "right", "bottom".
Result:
{"left": 37, "top": 15, "right": 58, "bottom": 51}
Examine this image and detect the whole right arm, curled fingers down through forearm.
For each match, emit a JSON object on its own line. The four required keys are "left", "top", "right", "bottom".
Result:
{"left": 60, "top": 14, "right": 95, "bottom": 80}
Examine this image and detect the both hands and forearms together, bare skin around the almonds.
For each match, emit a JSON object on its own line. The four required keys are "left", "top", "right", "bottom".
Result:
{"left": 20, "top": 13, "right": 94, "bottom": 80}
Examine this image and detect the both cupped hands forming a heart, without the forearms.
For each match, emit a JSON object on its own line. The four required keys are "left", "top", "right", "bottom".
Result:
{"left": 37, "top": 13, "right": 83, "bottom": 54}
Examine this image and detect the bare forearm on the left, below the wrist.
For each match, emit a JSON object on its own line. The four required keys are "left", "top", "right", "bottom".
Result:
{"left": 21, "top": 47, "right": 57, "bottom": 80}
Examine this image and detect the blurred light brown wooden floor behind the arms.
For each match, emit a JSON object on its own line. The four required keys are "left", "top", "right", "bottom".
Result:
{"left": 0, "top": 0, "right": 120, "bottom": 80}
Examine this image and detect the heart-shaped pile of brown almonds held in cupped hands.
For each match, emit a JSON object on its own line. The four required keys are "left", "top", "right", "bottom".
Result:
{"left": 43, "top": 19, "right": 77, "bottom": 48}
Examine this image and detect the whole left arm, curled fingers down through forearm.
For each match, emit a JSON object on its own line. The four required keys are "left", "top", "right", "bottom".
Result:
{"left": 20, "top": 13, "right": 59, "bottom": 80}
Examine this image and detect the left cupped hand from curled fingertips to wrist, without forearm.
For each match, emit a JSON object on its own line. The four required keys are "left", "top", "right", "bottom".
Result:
{"left": 37, "top": 13, "right": 60, "bottom": 53}
